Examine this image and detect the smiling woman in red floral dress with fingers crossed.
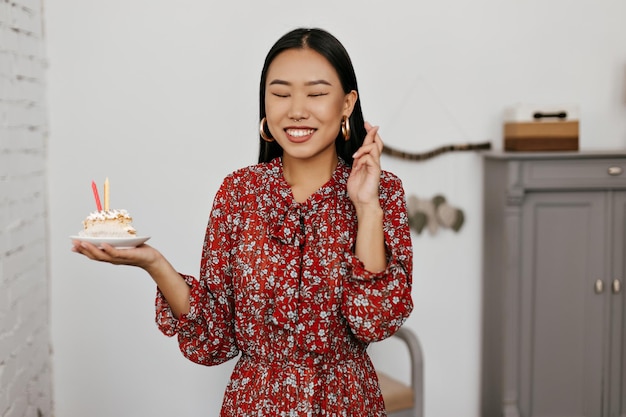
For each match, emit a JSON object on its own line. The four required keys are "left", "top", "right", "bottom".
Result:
{"left": 73, "top": 29, "right": 413, "bottom": 417}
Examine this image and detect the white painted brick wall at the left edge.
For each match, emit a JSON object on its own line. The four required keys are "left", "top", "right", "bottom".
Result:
{"left": 0, "top": 0, "right": 52, "bottom": 417}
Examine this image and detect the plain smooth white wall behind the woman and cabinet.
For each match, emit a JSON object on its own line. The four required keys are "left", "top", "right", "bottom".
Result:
{"left": 46, "top": 0, "right": 626, "bottom": 417}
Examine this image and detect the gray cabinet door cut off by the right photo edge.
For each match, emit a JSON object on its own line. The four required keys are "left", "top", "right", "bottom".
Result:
{"left": 608, "top": 191, "right": 626, "bottom": 417}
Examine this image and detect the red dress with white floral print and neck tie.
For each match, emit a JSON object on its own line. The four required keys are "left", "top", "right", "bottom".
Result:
{"left": 156, "top": 158, "right": 413, "bottom": 417}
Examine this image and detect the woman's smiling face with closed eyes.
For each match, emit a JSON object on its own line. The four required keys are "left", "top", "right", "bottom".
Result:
{"left": 265, "top": 48, "right": 357, "bottom": 164}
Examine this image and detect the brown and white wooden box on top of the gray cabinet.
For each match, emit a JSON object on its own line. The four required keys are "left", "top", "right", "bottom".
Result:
{"left": 504, "top": 105, "right": 579, "bottom": 152}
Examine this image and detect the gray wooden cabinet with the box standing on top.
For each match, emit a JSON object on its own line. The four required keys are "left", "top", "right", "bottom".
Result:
{"left": 481, "top": 152, "right": 626, "bottom": 417}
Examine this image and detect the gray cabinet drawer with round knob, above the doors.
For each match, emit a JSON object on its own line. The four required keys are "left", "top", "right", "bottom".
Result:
{"left": 522, "top": 158, "right": 626, "bottom": 189}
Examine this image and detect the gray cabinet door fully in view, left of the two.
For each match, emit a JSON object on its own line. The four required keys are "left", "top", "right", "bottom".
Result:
{"left": 518, "top": 192, "right": 610, "bottom": 417}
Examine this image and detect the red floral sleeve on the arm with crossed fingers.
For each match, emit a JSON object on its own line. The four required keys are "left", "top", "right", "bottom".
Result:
{"left": 341, "top": 174, "right": 413, "bottom": 342}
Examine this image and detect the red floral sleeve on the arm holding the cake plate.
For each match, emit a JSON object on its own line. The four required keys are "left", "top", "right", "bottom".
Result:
{"left": 156, "top": 174, "right": 239, "bottom": 365}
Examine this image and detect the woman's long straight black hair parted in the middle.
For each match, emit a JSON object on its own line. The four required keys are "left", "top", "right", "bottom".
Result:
{"left": 259, "top": 28, "right": 367, "bottom": 165}
